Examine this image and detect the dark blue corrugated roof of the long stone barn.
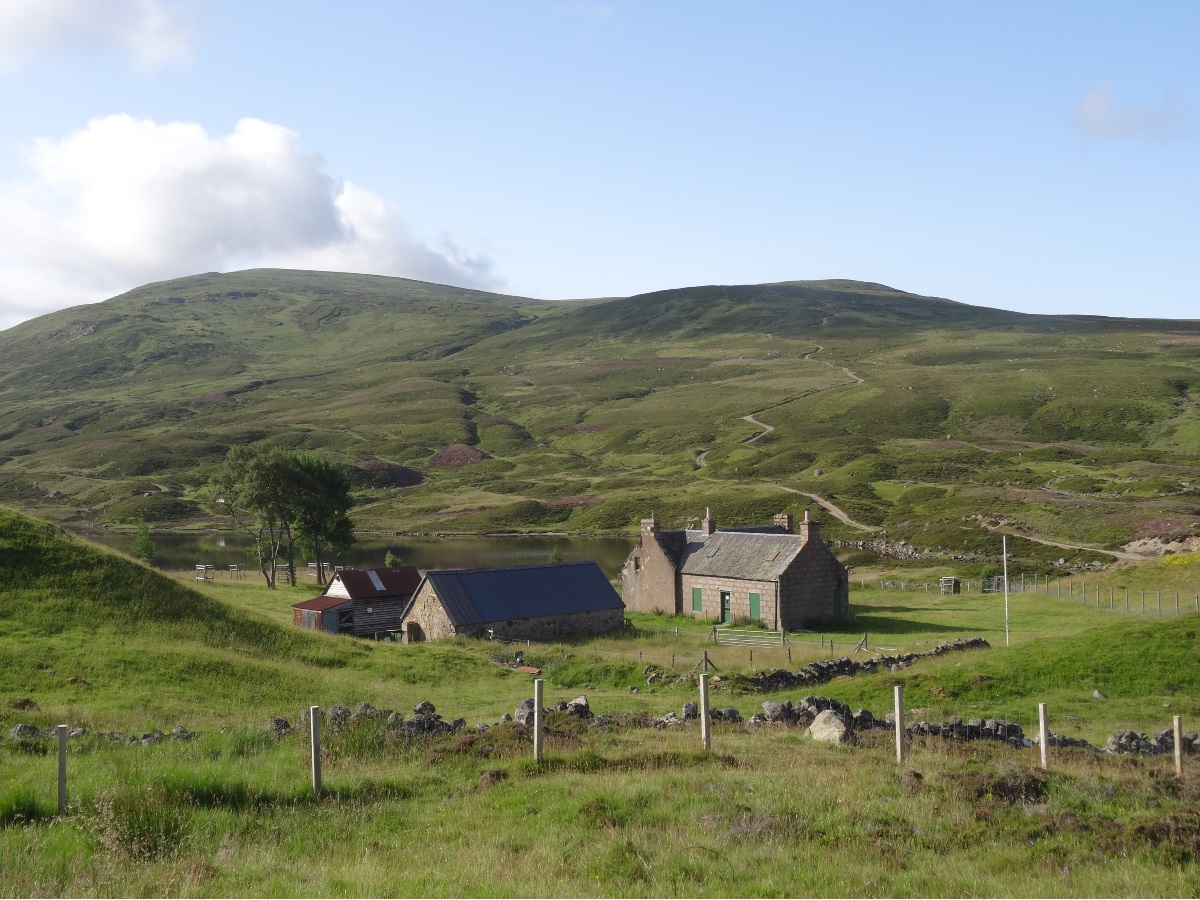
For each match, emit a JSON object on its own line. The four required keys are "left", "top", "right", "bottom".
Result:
{"left": 425, "top": 559, "right": 625, "bottom": 625}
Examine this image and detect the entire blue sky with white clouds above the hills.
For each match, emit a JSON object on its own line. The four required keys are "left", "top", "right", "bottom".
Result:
{"left": 0, "top": 0, "right": 1200, "bottom": 326}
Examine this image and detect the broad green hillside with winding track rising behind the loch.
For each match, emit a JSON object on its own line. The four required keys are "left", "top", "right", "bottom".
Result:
{"left": 0, "top": 270, "right": 1200, "bottom": 570}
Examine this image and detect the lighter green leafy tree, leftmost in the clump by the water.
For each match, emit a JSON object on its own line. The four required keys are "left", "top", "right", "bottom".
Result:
{"left": 214, "top": 442, "right": 298, "bottom": 589}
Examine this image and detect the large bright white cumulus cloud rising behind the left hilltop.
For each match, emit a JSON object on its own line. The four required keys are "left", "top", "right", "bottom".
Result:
{"left": 0, "top": 115, "right": 499, "bottom": 328}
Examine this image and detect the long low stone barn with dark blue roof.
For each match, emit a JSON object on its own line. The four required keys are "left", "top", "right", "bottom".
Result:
{"left": 403, "top": 560, "right": 625, "bottom": 643}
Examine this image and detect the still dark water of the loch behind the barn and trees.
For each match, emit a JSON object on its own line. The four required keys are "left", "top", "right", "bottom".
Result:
{"left": 73, "top": 529, "right": 635, "bottom": 578}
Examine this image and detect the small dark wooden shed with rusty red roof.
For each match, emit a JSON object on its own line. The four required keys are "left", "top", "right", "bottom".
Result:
{"left": 292, "top": 565, "right": 421, "bottom": 637}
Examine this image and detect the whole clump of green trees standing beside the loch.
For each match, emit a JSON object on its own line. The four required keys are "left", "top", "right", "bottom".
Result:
{"left": 214, "top": 442, "right": 354, "bottom": 588}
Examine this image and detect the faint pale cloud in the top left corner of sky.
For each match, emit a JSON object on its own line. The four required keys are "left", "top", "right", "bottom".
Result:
{"left": 0, "top": 0, "right": 193, "bottom": 71}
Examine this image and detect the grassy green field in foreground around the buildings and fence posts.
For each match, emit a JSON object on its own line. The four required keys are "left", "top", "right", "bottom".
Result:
{"left": 0, "top": 510, "right": 1200, "bottom": 896}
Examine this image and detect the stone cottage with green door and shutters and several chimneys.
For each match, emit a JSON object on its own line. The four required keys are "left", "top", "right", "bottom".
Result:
{"left": 620, "top": 509, "right": 850, "bottom": 631}
